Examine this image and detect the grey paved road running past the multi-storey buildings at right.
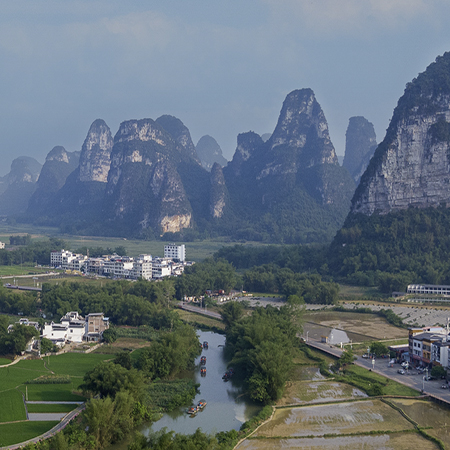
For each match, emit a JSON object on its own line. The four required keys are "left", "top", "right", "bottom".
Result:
{"left": 307, "top": 339, "right": 450, "bottom": 404}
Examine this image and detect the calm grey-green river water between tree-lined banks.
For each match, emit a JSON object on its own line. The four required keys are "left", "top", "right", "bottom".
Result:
{"left": 141, "top": 331, "right": 260, "bottom": 435}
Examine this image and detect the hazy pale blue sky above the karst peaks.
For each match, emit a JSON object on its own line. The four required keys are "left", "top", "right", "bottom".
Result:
{"left": 0, "top": 0, "right": 450, "bottom": 175}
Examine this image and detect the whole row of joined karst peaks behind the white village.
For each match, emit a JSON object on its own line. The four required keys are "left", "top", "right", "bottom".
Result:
{"left": 13, "top": 89, "right": 354, "bottom": 243}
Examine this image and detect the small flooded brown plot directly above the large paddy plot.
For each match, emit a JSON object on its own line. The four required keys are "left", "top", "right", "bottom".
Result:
{"left": 277, "top": 381, "right": 367, "bottom": 406}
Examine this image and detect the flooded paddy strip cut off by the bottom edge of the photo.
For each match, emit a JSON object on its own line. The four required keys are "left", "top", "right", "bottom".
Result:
{"left": 237, "top": 433, "right": 438, "bottom": 450}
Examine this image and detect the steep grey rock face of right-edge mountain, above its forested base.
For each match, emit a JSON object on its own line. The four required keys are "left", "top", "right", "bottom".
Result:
{"left": 351, "top": 52, "right": 450, "bottom": 215}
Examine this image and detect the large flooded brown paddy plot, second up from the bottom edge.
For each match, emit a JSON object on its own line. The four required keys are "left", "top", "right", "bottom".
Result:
{"left": 255, "top": 400, "right": 413, "bottom": 437}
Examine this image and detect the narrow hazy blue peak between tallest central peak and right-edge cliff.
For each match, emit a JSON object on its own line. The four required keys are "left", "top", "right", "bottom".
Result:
{"left": 343, "top": 116, "right": 377, "bottom": 184}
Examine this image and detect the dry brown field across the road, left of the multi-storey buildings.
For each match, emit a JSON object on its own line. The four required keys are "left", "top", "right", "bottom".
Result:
{"left": 304, "top": 311, "right": 407, "bottom": 342}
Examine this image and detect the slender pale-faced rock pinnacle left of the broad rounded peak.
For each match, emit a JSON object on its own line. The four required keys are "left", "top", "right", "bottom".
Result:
{"left": 79, "top": 119, "right": 113, "bottom": 183}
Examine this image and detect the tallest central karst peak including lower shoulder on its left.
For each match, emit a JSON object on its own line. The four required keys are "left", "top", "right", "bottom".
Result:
{"left": 224, "top": 89, "right": 354, "bottom": 243}
